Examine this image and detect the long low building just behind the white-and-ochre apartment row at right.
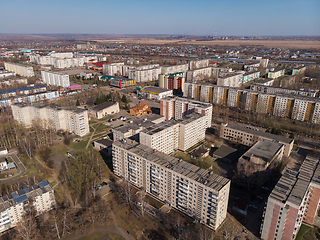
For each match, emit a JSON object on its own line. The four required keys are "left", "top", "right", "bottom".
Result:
{"left": 250, "top": 84, "right": 319, "bottom": 97}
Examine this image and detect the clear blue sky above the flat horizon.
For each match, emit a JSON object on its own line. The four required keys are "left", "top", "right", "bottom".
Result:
{"left": 0, "top": 0, "right": 320, "bottom": 36}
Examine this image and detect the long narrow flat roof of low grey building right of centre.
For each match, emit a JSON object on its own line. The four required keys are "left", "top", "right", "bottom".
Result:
{"left": 225, "top": 122, "right": 294, "bottom": 144}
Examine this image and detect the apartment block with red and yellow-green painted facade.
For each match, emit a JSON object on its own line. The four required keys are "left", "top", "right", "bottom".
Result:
{"left": 158, "top": 72, "right": 186, "bottom": 92}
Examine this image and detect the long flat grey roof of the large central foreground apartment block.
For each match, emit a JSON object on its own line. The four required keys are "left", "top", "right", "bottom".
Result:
{"left": 113, "top": 139, "right": 230, "bottom": 191}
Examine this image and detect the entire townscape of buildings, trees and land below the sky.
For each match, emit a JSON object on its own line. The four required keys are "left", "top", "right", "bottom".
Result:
{"left": 0, "top": 33, "right": 320, "bottom": 240}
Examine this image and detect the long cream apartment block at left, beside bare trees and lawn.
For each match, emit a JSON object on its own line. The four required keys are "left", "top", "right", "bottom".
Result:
{"left": 11, "top": 103, "right": 89, "bottom": 137}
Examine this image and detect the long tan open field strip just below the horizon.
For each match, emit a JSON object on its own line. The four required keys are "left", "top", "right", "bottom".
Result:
{"left": 96, "top": 38, "right": 320, "bottom": 49}
